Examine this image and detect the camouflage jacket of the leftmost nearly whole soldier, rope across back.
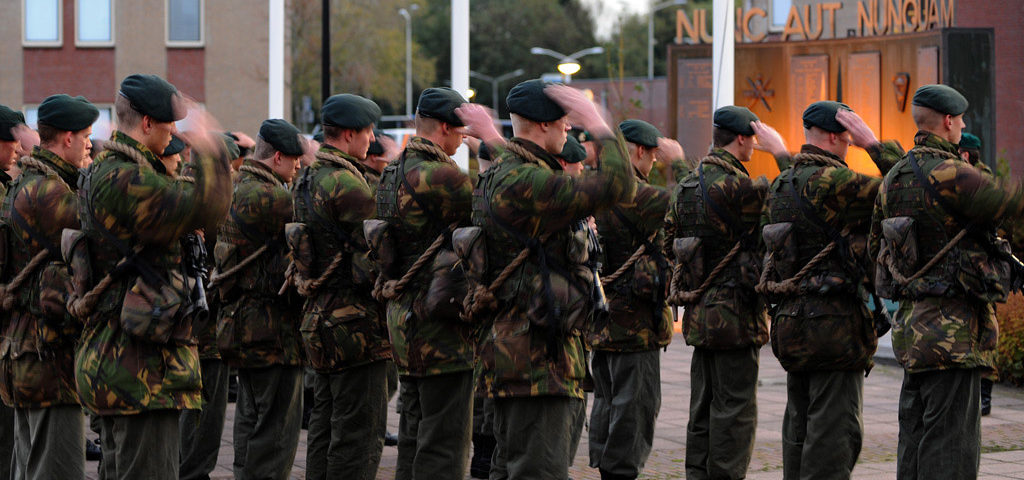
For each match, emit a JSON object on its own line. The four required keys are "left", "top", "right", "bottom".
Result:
{"left": 0, "top": 146, "right": 81, "bottom": 408}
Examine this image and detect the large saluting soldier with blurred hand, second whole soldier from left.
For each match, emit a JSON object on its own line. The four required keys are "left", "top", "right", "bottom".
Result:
{"left": 69, "top": 75, "right": 230, "bottom": 479}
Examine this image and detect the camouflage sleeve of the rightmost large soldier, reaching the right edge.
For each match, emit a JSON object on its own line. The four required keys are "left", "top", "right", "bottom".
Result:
{"left": 930, "top": 161, "right": 1024, "bottom": 224}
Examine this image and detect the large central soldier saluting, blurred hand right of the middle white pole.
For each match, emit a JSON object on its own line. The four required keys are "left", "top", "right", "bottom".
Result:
{"left": 473, "top": 80, "right": 636, "bottom": 479}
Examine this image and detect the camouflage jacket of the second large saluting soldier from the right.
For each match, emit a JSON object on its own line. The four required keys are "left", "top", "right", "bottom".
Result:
{"left": 761, "top": 142, "right": 902, "bottom": 372}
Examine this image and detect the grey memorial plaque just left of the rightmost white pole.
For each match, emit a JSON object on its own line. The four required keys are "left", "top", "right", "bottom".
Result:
{"left": 676, "top": 58, "right": 712, "bottom": 157}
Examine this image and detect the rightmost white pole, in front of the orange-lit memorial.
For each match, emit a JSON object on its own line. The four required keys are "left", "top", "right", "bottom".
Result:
{"left": 711, "top": 0, "right": 736, "bottom": 110}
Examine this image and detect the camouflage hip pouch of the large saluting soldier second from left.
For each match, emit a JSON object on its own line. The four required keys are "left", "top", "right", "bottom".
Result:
{"left": 121, "top": 271, "right": 195, "bottom": 344}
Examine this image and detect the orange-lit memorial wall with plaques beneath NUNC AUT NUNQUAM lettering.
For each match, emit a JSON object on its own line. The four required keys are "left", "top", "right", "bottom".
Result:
{"left": 668, "top": 28, "right": 995, "bottom": 178}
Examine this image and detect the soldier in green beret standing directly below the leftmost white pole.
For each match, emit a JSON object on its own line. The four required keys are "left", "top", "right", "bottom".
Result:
{"left": 211, "top": 119, "right": 304, "bottom": 479}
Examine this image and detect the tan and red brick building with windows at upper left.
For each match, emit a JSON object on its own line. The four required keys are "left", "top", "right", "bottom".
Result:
{"left": 0, "top": 0, "right": 291, "bottom": 136}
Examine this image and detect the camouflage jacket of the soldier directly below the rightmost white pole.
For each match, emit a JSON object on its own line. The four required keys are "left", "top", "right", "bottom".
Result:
{"left": 664, "top": 148, "right": 768, "bottom": 349}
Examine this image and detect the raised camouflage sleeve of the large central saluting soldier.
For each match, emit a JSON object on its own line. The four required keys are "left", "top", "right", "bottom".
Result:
{"left": 502, "top": 137, "right": 637, "bottom": 231}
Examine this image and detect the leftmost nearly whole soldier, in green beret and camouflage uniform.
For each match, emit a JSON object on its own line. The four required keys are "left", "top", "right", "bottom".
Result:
{"left": 0, "top": 94, "right": 99, "bottom": 478}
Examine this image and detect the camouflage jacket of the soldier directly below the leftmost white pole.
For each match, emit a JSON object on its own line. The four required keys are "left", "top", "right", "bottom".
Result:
{"left": 214, "top": 161, "right": 302, "bottom": 368}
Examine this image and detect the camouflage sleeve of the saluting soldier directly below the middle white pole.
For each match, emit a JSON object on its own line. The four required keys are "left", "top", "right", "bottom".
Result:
{"left": 409, "top": 162, "right": 473, "bottom": 224}
